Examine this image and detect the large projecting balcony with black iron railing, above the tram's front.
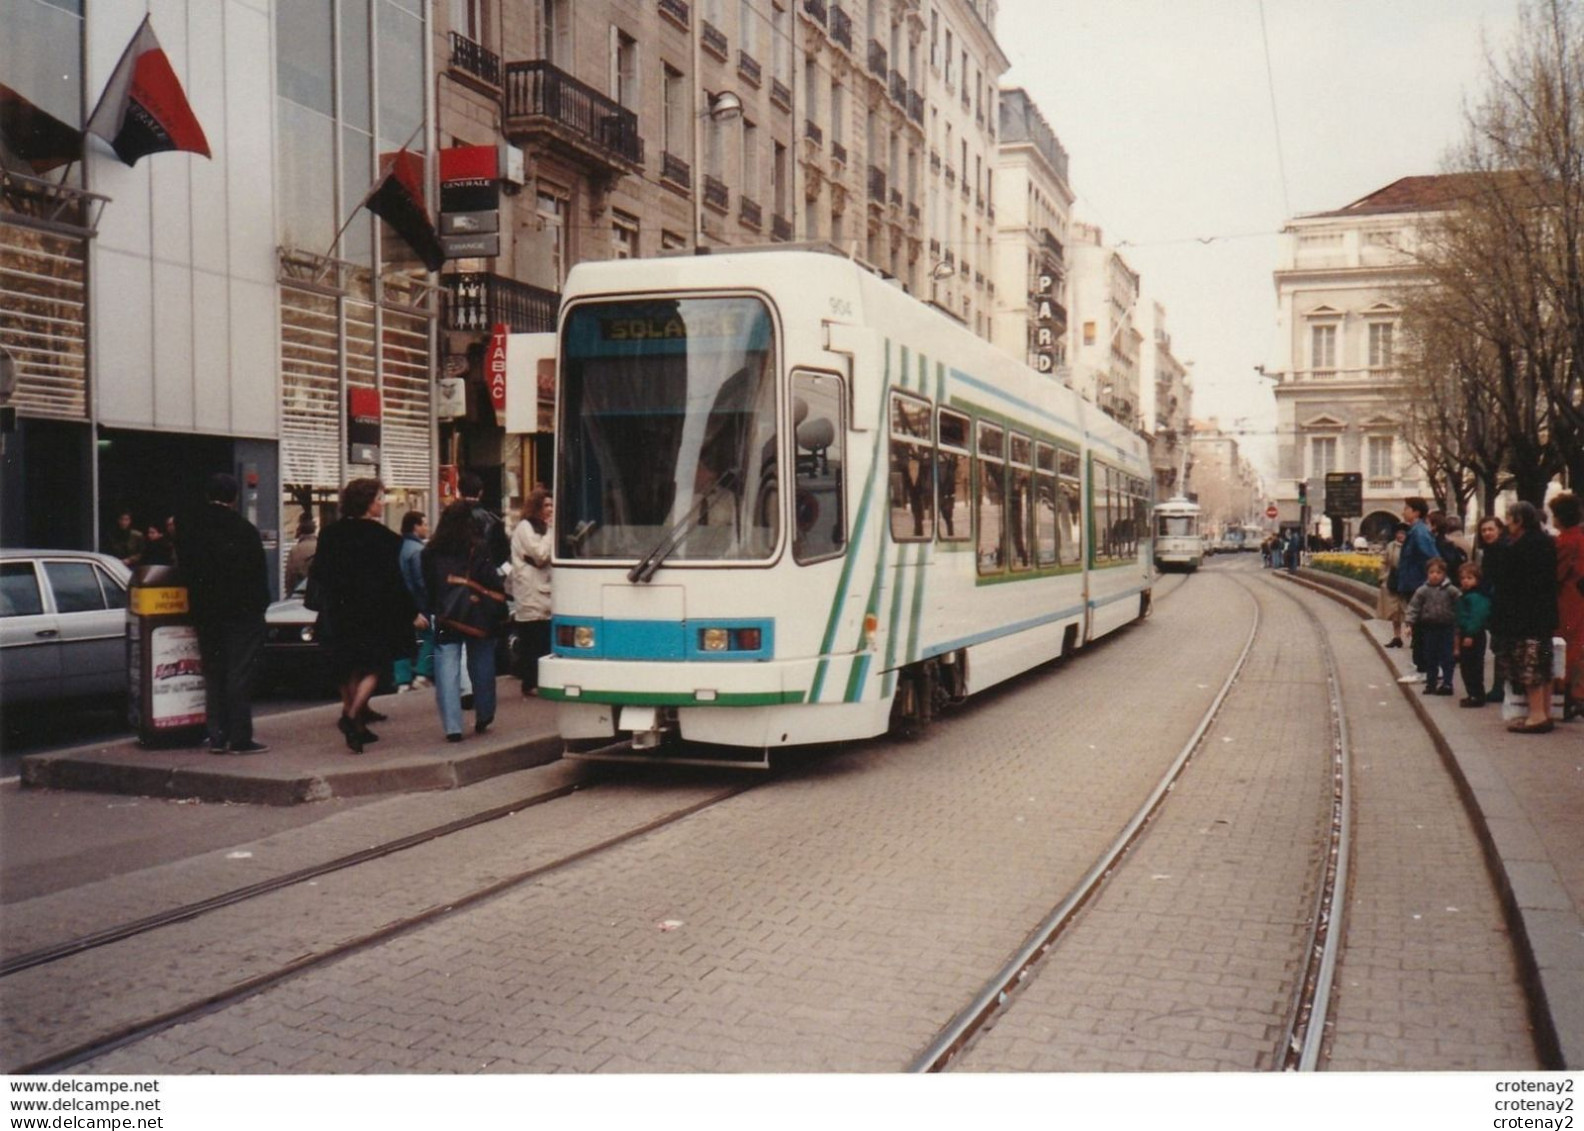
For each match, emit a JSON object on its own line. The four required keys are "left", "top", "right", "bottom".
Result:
{"left": 504, "top": 60, "right": 643, "bottom": 176}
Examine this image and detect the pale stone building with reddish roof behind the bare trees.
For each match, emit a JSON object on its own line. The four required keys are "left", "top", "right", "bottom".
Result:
{"left": 1267, "top": 176, "right": 1459, "bottom": 542}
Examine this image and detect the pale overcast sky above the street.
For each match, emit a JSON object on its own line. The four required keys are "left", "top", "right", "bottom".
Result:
{"left": 996, "top": 0, "right": 1517, "bottom": 478}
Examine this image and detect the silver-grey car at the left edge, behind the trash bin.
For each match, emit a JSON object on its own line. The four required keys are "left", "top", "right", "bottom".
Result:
{"left": 0, "top": 550, "right": 131, "bottom": 706}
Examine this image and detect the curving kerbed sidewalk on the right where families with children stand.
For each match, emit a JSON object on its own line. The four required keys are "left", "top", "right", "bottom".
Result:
{"left": 1297, "top": 570, "right": 1584, "bottom": 1069}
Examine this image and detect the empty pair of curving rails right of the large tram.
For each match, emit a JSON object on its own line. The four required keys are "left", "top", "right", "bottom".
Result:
{"left": 908, "top": 563, "right": 1351, "bottom": 1072}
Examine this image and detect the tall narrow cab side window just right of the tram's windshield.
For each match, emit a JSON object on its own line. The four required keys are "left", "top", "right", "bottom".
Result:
{"left": 792, "top": 372, "right": 847, "bottom": 564}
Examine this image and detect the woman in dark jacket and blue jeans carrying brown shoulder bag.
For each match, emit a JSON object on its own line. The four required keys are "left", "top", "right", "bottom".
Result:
{"left": 421, "top": 499, "right": 505, "bottom": 743}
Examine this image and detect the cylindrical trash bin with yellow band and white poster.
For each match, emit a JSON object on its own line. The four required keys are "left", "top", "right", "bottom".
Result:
{"left": 127, "top": 566, "right": 204, "bottom": 746}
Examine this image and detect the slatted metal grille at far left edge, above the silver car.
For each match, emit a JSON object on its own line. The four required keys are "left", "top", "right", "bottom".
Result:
{"left": 0, "top": 222, "right": 89, "bottom": 420}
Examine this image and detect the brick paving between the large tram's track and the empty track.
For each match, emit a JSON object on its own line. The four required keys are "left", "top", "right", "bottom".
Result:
{"left": 77, "top": 577, "right": 1251, "bottom": 1072}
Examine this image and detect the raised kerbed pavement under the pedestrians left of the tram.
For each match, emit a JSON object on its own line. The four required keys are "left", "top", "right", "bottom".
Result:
{"left": 22, "top": 678, "right": 562, "bottom": 805}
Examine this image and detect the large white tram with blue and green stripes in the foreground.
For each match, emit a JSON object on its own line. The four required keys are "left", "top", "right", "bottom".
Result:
{"left": 508, "top": 250, "right": 1152, "bottom": 759}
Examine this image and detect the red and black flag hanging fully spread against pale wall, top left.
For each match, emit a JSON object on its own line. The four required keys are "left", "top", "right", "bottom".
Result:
{"left": 87, "top": 16, "right": 209, "bottom": 165}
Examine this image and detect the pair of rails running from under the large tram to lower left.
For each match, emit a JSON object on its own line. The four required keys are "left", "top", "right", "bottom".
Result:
{"left": 0, "top": 744, "right": 782, "bottom": 1074}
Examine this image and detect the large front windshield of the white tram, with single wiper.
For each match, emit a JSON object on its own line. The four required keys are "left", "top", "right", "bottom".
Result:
{"left": 556, "top": 298, "right": 781, "bottom": 566}
